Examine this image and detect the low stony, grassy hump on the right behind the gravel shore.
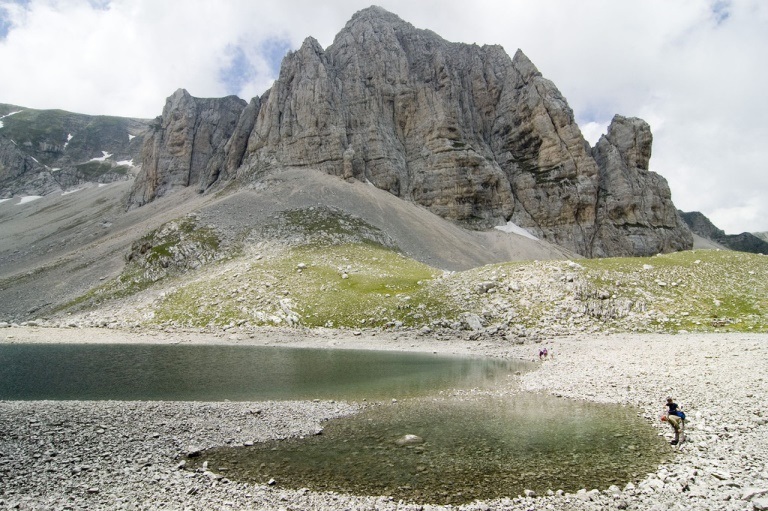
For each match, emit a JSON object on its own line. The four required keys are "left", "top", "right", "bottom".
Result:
{"left": 449, "top": 250, "right": 768, "bottom": 333}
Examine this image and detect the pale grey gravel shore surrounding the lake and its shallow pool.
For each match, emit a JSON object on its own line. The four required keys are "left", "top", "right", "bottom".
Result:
{"left": 0, "top": 327, "right": 768, "bottom": 511}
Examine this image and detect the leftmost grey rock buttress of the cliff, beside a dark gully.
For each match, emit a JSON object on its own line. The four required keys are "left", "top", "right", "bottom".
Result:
{"left": 128, "top": 89, "right": 246, "bottom": 207}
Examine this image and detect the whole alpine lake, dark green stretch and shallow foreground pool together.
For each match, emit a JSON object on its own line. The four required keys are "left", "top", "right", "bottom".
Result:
{"left": 0, "top": 344, "right": 670, "bottom": 504}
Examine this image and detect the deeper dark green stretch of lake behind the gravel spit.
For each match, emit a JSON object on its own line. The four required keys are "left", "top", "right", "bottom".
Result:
{"left": 0, "top": 344, "right": 530, "bottom": 401}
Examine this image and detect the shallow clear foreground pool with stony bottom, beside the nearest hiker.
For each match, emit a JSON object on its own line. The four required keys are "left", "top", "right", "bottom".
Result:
{"left": 189, "top": 394, "right": 668, "bottom": 504}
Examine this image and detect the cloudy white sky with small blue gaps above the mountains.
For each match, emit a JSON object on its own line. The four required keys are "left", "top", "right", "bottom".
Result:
{"left": 0, "top": 0, "right": 768, "bottom": 234}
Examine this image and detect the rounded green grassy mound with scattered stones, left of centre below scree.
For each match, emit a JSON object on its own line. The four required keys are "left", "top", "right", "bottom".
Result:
{"left": 155, "top": 243, "right": 458, "bottom": 328}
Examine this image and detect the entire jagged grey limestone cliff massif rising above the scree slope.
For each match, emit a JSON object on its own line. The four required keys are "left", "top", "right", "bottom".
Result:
{"left": 131, "top": 7, "right": 692, "bottom": 256}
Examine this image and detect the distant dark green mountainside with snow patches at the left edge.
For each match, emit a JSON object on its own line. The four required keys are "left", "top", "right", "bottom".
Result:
{"left": 0, "top": 104, "right": 150, "bottom": 198}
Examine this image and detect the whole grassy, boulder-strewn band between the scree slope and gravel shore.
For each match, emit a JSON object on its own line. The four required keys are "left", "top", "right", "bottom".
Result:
{"left": 60, "top": 202, "right": 768, "bottom": 337}
